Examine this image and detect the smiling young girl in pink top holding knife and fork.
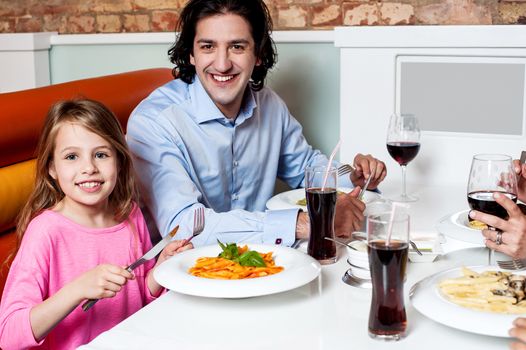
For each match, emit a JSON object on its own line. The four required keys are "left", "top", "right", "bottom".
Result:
{"left": 0, "top": 100, "right": 187, "bottom": 350}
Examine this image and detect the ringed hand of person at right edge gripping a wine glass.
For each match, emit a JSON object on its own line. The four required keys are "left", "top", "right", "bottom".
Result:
{"left": 469, "top": 193, "right": 526, "bottom": 259}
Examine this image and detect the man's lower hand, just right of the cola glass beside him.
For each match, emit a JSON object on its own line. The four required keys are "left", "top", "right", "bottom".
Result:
{"left": 334, "top": 186, "right": 368, "bottom": 237}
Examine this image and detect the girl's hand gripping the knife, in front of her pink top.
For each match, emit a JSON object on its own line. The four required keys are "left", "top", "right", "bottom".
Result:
{"left": 69, "top": 264, "right": 135, "bottom": 300}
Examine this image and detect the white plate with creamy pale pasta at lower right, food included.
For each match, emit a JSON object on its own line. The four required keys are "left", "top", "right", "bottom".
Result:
{"left": 409, "top": 266, "right": 526, "bottom": 337}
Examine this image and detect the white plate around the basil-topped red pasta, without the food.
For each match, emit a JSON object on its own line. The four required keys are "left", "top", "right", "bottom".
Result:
{"left": 153, "top": 244, "right": 321, "bottom": 298}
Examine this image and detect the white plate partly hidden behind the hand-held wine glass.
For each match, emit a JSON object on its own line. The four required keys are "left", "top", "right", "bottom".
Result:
{"left": 436, "top": 210, "right": 484, "bottom": 245}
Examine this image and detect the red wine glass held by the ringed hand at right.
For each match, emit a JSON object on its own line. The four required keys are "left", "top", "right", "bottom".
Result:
{"left": 467, "top": 154, "right": 517, "bottom": 265}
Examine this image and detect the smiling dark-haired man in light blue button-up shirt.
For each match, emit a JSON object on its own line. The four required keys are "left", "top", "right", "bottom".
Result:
{"left": 127, "top": 0, "right": 386, "bottom": 246}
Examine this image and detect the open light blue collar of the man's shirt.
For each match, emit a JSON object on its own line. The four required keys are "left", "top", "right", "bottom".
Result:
{"left": 188, "top": 74, "right": 257, "bottom": 124}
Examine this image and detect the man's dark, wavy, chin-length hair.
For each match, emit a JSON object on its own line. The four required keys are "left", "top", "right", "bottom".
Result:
{"left": 168, "top": 0, "right": 276, "bottom": 91}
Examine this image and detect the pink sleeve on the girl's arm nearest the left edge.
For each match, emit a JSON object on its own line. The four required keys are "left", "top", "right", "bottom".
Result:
{"left": 0, "top": 229, "right": 49, "bottom": 350}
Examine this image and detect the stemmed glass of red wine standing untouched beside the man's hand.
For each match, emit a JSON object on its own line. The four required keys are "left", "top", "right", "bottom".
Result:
{"left": 387, "top": 114, "right": 420, "bottom": 202}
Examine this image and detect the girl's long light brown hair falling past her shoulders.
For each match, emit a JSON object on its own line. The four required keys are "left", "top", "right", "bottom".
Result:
{"left": 16, "top": 99, "right": 138, "bottom": 250}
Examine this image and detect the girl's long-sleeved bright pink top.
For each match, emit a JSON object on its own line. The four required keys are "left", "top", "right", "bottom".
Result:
{"left": 0, "top": 206, "right": 155, "bottom": 350}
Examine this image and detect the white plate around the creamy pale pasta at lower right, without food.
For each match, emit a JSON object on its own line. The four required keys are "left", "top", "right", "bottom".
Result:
{"left": 409, "top": 266, "right": 526, "bottom": 337}
